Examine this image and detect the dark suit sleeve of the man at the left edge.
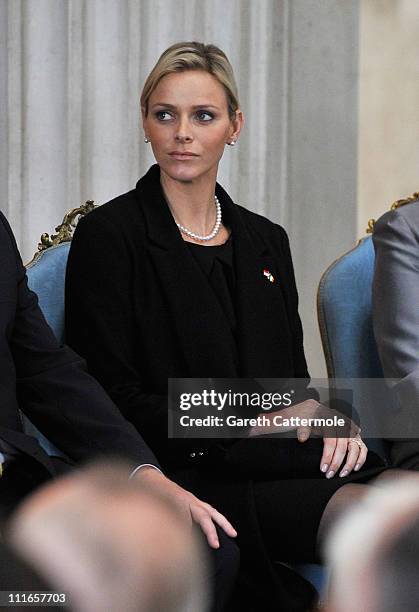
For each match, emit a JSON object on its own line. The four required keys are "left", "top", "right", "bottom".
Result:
{"left": 0, "top": 215, "right": 158, "bottom": 466}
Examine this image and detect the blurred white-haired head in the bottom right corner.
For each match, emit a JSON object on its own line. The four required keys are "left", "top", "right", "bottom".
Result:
{"left": 326, "top": 475, "right": 419, "bottom": 612}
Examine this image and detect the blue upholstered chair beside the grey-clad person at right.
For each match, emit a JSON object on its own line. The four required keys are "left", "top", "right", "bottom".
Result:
{"left": 317, "top": 232, "right": 390, "bottom": 457}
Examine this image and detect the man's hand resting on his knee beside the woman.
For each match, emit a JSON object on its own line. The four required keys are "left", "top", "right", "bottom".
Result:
{"left": 133, "top": 467, "right": 237, "bottom": 548}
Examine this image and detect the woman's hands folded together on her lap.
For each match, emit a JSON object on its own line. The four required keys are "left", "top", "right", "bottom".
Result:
{"left": 249, "top": 399, "right": 368, "bottom": 478}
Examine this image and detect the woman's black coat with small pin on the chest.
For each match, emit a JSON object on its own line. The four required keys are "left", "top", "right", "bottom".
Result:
{"left": 66, "top": 165, "right": 318, "bottom": 612}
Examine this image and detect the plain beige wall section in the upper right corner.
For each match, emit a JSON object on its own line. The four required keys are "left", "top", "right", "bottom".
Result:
{"left": 358, "top": 0, "right": 419, "bottom": 236}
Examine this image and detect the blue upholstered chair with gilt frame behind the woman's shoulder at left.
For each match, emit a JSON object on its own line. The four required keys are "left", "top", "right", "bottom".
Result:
{"left": 23, "top": 200, "right": 94, "bottom": 456}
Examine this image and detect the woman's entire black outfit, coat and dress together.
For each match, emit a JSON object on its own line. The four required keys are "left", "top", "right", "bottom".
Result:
{"left": 66, "top": 166, "right": 385, "bottom": 612}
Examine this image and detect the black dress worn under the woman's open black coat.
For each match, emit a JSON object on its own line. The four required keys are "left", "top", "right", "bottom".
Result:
{"left": 187, "top": 235, "right": 385, "bottom": 563}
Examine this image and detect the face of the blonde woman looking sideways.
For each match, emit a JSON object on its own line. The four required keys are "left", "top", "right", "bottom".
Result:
{"left": 143, "top": 70, "right": 243, "bottom": 182}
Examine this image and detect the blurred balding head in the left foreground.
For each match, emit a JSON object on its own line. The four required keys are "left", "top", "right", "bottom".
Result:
{"left": 8, "top": 463, "right": 209, "bottom": 612}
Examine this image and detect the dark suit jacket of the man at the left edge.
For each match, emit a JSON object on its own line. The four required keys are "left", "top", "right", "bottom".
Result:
{"left": 0, "top": 213, "right": 160, "bottom": 474}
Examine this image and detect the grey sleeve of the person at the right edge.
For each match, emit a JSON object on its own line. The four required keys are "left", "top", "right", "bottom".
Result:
{"left": 373, "top": 203, "right": 419, "bottom": 469}
